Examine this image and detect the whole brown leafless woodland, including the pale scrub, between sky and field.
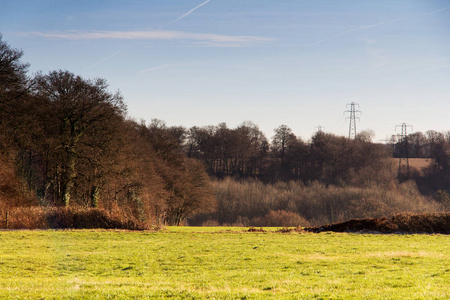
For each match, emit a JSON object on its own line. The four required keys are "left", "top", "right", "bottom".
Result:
{"left": 0, "top": 35, "right": 450, "bottom": 229}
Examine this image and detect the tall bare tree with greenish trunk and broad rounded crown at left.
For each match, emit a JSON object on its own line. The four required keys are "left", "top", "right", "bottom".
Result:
{"left": 35, "top": 70, "right": 125, "bottom": 206}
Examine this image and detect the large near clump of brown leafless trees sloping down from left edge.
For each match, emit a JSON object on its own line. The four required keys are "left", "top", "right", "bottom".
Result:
{"left": 0, "top": 35, "right": 214, "bottom": 224}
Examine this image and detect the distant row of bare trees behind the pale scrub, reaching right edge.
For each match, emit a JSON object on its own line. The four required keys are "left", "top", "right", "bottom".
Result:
{"left": 154, "top": 116, "right": 450, "bottom": 191}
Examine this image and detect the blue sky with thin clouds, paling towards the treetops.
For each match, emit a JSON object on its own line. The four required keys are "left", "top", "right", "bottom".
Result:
{"left": 0, "top": 0, "right": 450, "bottom": 141}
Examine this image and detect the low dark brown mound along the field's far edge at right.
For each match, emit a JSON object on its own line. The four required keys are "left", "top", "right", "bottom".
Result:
{"left": 305, "top": 212, "right": 450, "bottom": 234}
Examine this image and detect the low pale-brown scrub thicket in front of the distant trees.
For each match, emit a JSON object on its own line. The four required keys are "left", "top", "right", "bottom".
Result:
{"left": 189, "top": 178, "right": 443, "bottom": 226}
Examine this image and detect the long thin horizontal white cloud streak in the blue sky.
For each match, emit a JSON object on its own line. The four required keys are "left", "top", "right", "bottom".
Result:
{"left": 23, "top": 30, "right": 272, "bottom": 43}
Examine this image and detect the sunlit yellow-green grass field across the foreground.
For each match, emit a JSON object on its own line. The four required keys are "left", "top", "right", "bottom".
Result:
{"left": 0, "top": 227, "right": 450, "bottom": 299}
